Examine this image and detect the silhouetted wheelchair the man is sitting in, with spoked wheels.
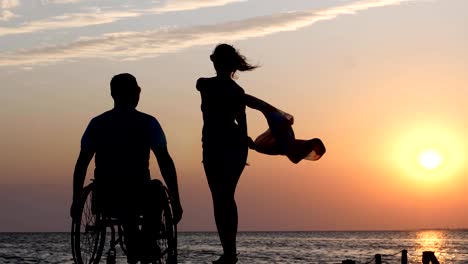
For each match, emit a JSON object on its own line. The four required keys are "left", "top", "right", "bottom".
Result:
{"left": 71, "top": 180, "right": 177, "bottom": 264}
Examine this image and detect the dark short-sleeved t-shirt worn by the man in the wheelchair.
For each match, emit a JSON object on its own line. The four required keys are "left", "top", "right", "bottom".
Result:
{"left": 81, "top": 108, "right": 167, "bottom": 200}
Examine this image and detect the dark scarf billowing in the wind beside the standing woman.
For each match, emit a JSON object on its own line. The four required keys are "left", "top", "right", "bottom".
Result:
{"left": 245, "top": 94, "right": 325, "bottom": 163}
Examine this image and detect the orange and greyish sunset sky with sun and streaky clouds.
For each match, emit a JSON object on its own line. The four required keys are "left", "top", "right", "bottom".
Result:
{"left": 0, "top": 0, "right": 468, "bottom": 232}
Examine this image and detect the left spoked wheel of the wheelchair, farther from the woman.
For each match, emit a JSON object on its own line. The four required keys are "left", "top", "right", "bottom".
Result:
{"left": 71, "top": 183, "right": 106, "bottom": 264}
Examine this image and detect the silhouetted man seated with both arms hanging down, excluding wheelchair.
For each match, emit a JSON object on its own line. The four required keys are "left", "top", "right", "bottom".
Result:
{"left": 70, "top": 73, "right": 182, "bottom": 263}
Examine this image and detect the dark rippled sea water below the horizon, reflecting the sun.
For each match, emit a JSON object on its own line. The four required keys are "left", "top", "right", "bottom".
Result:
{"left": 0, "top": 230, "right": 468, "bottom": 264}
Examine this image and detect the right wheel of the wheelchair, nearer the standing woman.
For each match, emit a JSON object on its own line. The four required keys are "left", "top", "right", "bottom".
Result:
{"left": 157, "top": 185, "right": 177, "bottom": 264}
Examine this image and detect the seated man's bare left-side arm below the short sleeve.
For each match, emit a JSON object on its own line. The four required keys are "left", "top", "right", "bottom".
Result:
{"left": 70, "top": 149, "right": 94, "bottom": 218}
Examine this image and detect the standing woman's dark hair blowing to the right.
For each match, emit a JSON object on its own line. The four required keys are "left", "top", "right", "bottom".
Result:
{"left": 210, "top": 43, "right": 259, "bottom": 74}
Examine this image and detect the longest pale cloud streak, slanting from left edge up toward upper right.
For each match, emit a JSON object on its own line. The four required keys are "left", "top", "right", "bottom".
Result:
{"left": 0, "top": 0, "right": 419, "bottom": 66}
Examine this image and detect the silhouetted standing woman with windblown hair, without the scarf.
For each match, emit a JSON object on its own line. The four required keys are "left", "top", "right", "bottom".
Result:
{"left": 197, "top": 44, "right": 256, "bottom": 264}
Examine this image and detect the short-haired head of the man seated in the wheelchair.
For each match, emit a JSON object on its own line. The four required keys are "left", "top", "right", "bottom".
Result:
{"left": 110, "top": 73, "right": 141, "bottom": 108}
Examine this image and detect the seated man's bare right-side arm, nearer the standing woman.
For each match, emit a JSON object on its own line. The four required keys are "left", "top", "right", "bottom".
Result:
{"left": 153, "top": 146, "right": 183, "bottom": 223}
